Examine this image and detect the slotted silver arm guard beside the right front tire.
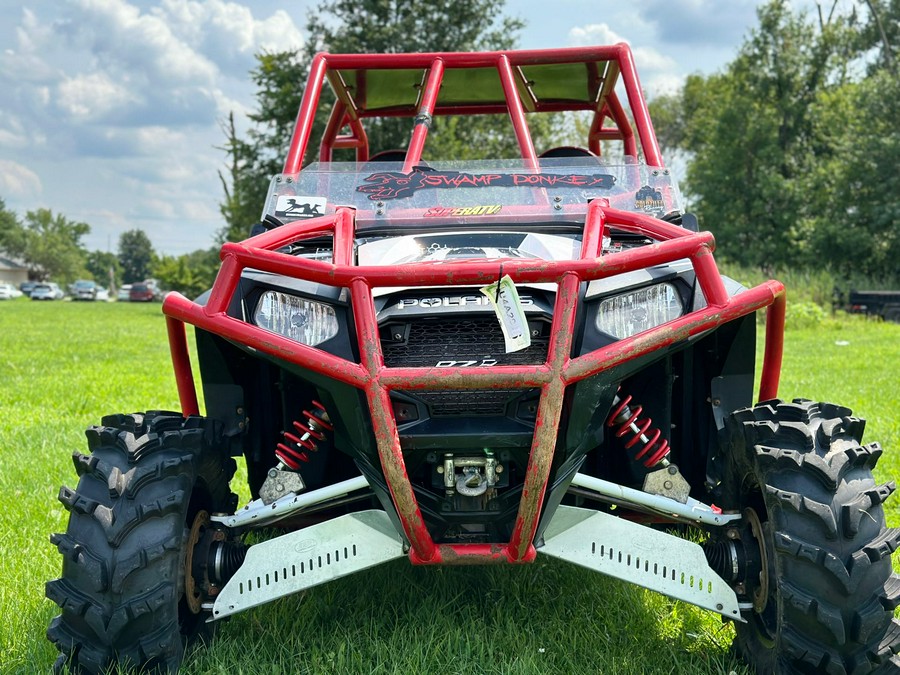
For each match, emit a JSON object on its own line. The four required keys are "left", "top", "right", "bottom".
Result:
{"left": 538, "top": 506, "right": 742, "bottom": 621}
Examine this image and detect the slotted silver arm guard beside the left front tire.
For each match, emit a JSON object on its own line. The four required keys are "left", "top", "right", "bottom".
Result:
{"left": 211, "top": 510, "right": 405, "bottom": 620}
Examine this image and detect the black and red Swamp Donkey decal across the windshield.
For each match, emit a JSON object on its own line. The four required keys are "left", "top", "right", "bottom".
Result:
{"left": 356, "top": 169, "right": 616, "bottom": 201}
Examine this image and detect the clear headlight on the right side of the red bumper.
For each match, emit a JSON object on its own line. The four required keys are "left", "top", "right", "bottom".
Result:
{"left": 597, "top": 284, "right": 684, "bottom": 339}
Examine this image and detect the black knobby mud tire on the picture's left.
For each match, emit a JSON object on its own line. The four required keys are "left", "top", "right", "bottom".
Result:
{"left": 46, "top": 412, "right": 237, "bottom": 673}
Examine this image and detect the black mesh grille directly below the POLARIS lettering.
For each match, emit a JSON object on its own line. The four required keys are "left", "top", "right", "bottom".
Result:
{"left": 382, "top": 315, "right": 548, "bottom": 368}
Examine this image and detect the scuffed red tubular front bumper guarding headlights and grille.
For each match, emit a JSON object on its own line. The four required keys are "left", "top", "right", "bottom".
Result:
{"left": 163, "top": 201, "right": 785, "bottom": 564}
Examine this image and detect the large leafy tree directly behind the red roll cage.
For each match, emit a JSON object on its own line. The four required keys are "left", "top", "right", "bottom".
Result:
{"left": 221, "top": 0, "right": 558, "bottom": 240}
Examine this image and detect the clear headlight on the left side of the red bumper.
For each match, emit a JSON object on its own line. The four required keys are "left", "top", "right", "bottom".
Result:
{"left": 253, "top": 291, "right": 338, "bottom": 346}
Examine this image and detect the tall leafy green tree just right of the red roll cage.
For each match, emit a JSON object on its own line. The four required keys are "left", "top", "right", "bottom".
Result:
{"left": 655, "top": 0, "right": 852, "bottom": 269}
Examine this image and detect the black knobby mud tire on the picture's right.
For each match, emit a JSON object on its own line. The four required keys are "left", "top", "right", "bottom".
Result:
{"left": 722, "top": 399, "right": 900, "bottom": 675}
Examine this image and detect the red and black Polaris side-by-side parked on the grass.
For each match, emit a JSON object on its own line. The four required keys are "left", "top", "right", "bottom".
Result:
{"left": 47, "top": 44, "right": 900, "bottom": 675}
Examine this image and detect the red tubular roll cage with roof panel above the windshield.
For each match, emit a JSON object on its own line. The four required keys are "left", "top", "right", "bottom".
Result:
{"left": 284, "top": 43, "right": 663, "bottom": 174}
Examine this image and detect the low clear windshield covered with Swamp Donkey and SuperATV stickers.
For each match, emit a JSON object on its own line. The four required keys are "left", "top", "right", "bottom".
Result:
{"left": 263, "top": 157, "right": 683, "bottom": 230}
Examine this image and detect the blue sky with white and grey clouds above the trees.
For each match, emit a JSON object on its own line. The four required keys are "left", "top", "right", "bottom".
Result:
{"left": 0, "top": 0, "right": 816, "bottom": 255}
